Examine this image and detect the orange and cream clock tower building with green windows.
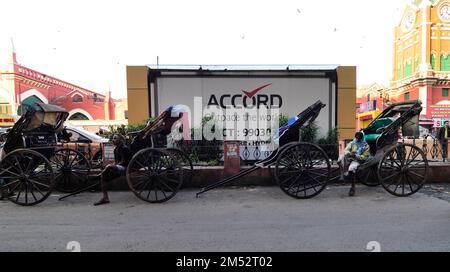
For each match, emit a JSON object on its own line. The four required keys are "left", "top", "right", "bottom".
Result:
{"left": 385, "top": 0, "right": 450, "bottom": 128}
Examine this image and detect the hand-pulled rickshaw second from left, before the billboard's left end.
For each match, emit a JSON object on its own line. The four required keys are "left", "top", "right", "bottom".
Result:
{"left": 60, "top": 106, "right": 193, "bottom": 203}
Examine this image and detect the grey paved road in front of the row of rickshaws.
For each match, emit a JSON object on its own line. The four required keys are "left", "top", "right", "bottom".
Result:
{"left": 0, "top": 185, "right": 450, "bottom": 251}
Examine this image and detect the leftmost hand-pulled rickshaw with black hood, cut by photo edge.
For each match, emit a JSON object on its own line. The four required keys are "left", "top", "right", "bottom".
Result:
{"left": 0, "top": 103, "right": 90, "bottom": 206}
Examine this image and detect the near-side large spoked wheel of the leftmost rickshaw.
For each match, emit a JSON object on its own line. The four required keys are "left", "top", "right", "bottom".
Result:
{"left": 0, "top": 149, "right": 55, "bottom": 206}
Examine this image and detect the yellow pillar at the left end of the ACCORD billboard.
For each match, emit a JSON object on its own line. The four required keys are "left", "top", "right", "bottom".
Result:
{"left": 127, "top": 66, "right": 150, "bottom": 125}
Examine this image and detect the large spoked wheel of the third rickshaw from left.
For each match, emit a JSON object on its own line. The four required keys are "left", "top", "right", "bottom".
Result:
{"left": 274, "top": 143, "right": 331, "bottom": 199}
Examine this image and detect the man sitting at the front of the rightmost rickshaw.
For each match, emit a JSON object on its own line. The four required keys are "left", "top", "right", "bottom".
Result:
{"left": 338, "top": 132, "right": 370, "bottom": 196}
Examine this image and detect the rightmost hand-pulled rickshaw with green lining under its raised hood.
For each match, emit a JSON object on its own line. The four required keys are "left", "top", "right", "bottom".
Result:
{"left": 356, "top": 101, "right": 428, "bottom": 197}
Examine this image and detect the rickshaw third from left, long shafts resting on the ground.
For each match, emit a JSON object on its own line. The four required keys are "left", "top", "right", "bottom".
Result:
{"left": 197, "top": 101, "right": 331, "bottom": 199}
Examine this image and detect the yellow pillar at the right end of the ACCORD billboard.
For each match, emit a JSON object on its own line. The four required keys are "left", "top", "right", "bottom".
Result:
{"left": 337, "top": 66, "right": 356, "bottom": 140}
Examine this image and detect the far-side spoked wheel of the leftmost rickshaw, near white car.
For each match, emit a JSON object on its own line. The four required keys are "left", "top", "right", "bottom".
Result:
{"left": 50, "top": 148, "right": 91, "bottom": 193}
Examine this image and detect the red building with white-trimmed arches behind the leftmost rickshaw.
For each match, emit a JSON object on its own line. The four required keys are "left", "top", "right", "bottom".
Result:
{"left": 0, "top": 52, "right": 115, "bottom": 124}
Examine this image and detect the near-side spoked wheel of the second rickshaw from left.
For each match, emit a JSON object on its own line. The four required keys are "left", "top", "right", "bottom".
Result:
{"left": 127, "top": 148, "right": 183, "bottom": 203}
